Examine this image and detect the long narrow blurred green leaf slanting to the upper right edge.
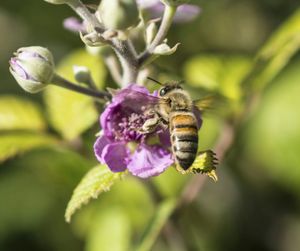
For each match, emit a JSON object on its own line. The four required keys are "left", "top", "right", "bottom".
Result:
{"left": 243, "top": 9, "right": 300, "bottom": 90}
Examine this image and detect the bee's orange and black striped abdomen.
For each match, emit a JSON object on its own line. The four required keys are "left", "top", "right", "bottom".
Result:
{"left": 170, "top": 111, "right": 198, "bottom": 170}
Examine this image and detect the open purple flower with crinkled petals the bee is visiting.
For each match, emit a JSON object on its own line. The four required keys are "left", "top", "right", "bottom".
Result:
{"left": 94, "top": 84, "right": 174, "bottom": 178}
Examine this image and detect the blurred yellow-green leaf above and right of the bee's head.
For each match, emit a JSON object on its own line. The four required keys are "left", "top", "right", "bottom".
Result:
{"left": 184, "top": 54, "right": 251, "bottom": 99}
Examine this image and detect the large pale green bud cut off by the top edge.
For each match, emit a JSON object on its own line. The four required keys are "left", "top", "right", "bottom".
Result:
{"left": 99, "top": 0, "right": 139, "bottom": 30}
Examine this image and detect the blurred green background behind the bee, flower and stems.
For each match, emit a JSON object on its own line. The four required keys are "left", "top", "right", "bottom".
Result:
{"left": 0, "top": 0, "right": 300, "bottom": 251}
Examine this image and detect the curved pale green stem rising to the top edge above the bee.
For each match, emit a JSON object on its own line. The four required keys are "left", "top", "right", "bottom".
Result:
{"left": 138, "top": 5, "right": 177, "bottom": 65}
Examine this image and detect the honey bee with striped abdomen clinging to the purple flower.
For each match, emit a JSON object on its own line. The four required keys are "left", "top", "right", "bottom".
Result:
{"left": 142, "top": 78, "right": 216, "bottom": 176}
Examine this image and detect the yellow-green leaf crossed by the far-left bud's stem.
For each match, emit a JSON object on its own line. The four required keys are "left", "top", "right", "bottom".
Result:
{"left": 44, "top": 50, "right": 105, "bottom": 140}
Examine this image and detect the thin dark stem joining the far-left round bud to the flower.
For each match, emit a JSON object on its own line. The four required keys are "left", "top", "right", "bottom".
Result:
{"left": 51, "top": 74, "right": 111, "bottom": 102}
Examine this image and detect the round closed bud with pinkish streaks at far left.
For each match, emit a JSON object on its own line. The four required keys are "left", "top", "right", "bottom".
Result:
{"left": 9, "top": 46, "right": 54, "bottom": 93}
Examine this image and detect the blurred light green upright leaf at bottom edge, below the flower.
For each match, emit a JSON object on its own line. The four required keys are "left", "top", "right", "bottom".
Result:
{"left": 85, "top": 207, "right": 131, "bottom": 251}
